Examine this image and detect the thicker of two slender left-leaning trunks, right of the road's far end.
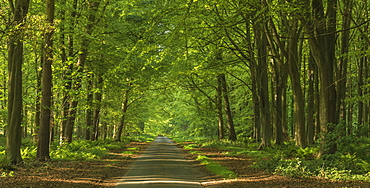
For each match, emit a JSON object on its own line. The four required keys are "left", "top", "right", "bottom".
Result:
{"left": 219, "top": 74, "right": 236, "bottom": 141}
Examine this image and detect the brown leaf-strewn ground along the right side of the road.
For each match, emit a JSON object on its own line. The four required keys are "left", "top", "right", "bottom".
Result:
{"left": 181, "top": 142, "right": 370, "bottom": 188}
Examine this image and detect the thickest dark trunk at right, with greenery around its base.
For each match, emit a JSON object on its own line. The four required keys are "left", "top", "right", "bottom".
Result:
{"left": 303, "top": 0, "right": 339, "bottom": 156}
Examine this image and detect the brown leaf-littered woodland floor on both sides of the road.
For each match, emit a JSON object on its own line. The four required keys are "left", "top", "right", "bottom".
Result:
{"left": 0, "top": 142, "right": 370, "bottom": 188}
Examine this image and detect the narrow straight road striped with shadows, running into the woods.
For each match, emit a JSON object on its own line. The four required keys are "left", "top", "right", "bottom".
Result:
{"left": 117, "top": 136, "right": 202, "bottom": 188}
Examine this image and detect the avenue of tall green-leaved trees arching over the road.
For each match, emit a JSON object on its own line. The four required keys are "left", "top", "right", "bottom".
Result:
{"left": 0, "top": 0, "right": 370, "bottom": 164}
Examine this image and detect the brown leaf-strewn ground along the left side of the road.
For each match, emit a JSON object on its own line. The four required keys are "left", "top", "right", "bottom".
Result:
{"left": 0, "top": 142, "right": 149, "bottom": 188}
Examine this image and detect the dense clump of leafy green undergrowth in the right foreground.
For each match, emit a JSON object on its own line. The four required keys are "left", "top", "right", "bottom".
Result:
{"left": 251, "top": 137, "right": 370, "bottom": 181}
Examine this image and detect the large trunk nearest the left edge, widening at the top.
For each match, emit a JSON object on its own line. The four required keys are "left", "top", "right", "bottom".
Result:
{"left": 5, "top": 0, "right": 29, "bottom": 164}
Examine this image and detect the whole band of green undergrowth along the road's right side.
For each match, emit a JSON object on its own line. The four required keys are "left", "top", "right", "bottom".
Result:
{"left": 177, "top": 137, "right": 370, "bottom": 181}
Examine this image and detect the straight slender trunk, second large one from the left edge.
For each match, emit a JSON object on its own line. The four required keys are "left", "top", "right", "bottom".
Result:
{"left": 36, "top": 0, "right": 55, "bottom": 161}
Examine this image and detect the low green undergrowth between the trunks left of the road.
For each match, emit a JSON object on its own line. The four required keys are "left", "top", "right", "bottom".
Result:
{"left": 0, "top": 134, "right": 155, "bottom": 176}
